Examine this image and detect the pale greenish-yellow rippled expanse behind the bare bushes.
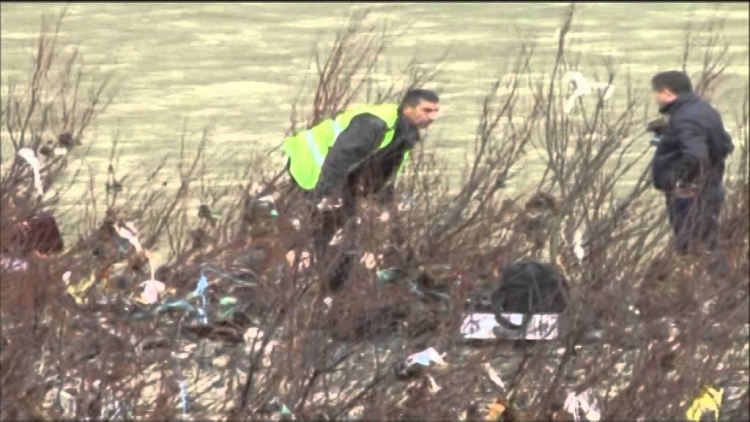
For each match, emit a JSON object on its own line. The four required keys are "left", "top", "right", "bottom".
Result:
{"left": 2, "top": 3, "right": 749, "bottom": 214}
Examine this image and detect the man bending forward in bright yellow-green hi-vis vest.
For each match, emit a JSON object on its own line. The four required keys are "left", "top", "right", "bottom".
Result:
{"left": 283, "top": 89, "right": 439, "bottom": 290}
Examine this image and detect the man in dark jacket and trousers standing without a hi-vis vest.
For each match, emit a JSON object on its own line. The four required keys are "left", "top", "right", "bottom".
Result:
{"left": 651, "top": 71, "right": 734, "bottom": 258}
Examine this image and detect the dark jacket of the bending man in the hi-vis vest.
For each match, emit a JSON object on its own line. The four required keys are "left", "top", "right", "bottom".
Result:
{"left": 315, "top": 113, "right": 419, "bottom": 202}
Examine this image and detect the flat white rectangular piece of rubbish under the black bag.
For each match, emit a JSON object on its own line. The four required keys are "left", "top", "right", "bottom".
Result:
{"left": 460, "top": 313, "right": 560, "bottom": 340}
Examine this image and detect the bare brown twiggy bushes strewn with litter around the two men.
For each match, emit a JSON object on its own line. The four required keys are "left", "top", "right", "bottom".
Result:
{"left": 0, "top": 6, "right": 750, "bottom": 420}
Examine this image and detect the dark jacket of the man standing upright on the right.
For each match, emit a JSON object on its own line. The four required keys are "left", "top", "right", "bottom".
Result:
{"left": 652, "top": 93, "right": 734, "bottom": 192}
